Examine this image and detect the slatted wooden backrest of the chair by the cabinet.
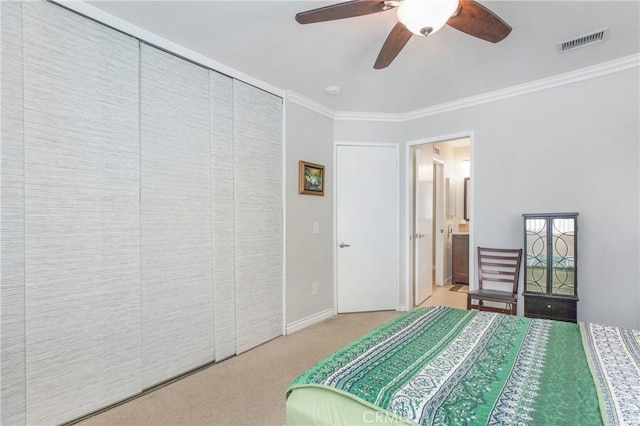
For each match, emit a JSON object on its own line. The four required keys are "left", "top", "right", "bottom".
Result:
{"left": 478, "top": 247, "right": 522, "bottom": 294}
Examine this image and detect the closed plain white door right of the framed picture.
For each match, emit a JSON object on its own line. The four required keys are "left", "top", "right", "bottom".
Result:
{"left": 336, "top": 145, "right": 399, "bottom": 312}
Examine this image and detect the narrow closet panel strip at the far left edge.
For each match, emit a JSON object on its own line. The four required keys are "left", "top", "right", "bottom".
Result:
{"left": 0, "top": 1, "right": 26, "bottom": 425}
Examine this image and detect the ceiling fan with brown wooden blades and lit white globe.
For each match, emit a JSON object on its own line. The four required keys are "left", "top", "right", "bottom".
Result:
{"left": 296, "top": 0, "right": 511, "bottom": 69}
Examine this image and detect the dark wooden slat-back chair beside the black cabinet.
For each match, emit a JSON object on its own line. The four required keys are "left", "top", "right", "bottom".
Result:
{"left": 467, "top": 247, "right": 522, "bottom": 315}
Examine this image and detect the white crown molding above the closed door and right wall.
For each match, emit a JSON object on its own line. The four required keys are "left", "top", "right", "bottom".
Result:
{"left": 335, "top": 53, "right": 640, "bottom": 122}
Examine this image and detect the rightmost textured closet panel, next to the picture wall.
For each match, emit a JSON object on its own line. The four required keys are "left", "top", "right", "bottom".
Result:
{"left": 233, "top": 81, "right": 283, "bottom": 353}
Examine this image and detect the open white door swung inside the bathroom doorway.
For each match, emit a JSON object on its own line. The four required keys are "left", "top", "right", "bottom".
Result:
{"left": 413, "top": 145, "right": 433, "bottom": 306}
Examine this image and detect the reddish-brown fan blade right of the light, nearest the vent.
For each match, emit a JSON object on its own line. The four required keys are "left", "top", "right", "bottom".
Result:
{"left": 447, "top": 0, "right": 511, "bottom": 43}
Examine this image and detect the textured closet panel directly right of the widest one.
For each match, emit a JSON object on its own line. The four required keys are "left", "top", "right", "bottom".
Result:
{"left": 140, "top": 44, "right": 214, "bottom": 388}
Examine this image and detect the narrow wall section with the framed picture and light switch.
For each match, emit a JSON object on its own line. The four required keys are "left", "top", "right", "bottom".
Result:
{"left": 285, "top": 101, "right": 334, "bottom": 331}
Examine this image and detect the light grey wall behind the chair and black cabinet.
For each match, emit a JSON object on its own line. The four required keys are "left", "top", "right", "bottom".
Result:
{"left": 401, "top": 68, "right": 640, "bottom": 329}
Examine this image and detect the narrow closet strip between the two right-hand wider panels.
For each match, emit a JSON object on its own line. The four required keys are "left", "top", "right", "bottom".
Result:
{"left": 209, "top": 71, "right": 236, "bottom": 360}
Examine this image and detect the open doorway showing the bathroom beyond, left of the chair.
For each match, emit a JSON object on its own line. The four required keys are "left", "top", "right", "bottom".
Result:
{"left": 407, "top": 136, "right": 473, "bottom": 307}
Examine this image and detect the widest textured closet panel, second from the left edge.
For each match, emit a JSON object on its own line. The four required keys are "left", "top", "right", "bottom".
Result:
{"left": 21, "top": 2, "right": 141, "bottom": 425}
